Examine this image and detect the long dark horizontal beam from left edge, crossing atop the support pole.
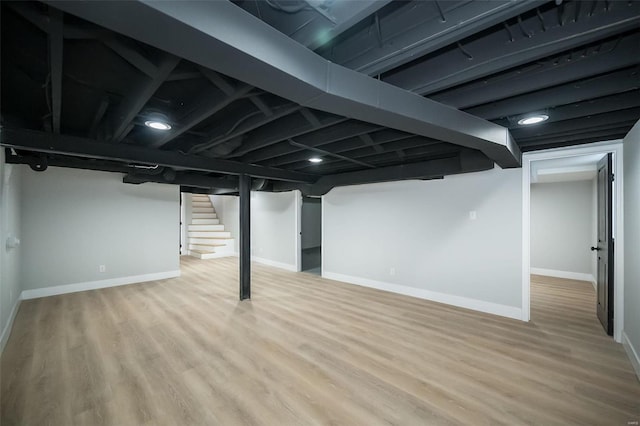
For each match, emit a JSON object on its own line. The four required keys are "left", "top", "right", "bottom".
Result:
{"left": 0, "top": 127, "right": 317, "bottom": 183}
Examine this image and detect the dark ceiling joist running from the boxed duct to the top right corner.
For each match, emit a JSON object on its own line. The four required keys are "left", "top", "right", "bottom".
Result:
{"left": 385, "top": 1, "right": 640, "bottom": 95}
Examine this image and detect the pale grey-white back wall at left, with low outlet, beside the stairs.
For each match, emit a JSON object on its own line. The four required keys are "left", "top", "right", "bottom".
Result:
{"left": 21, "top": 167, "right": 180, "bottom": 296}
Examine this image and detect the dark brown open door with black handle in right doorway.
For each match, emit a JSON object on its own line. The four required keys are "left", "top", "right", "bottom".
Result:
{"left": 591, "top": 154, "right": 613, "bottom": 336}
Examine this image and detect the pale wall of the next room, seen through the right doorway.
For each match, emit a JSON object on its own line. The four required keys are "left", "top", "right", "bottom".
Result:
{"left": 531, "top": 180, "right": 596, "bottom": 281}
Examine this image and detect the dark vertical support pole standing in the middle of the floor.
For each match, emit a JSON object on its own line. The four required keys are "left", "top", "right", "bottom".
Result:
{"left": 238, "top": 174, "right": 251, "bottom": 300}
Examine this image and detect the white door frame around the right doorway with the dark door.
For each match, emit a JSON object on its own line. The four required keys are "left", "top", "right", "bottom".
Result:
{"left": 522, "top": 139, "right": 624, "bottom": 343}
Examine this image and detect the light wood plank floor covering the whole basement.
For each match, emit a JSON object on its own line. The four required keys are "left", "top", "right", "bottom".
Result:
{"left": 0, "top": 258, "right": 640, "bottom": 426}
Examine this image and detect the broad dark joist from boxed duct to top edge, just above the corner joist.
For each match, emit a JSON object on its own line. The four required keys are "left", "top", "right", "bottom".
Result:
{"left": 321, "top": 0, "right": 545, "bottom": 76}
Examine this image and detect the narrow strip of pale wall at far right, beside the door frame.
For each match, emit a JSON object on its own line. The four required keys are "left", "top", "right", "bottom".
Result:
{"left": 623, "top": 121, "right": 640, "bottom": 377}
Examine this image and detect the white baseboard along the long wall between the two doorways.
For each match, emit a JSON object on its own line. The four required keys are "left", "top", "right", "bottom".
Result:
{"left": 322, "top": 271, "right": 522, "bottom": 320}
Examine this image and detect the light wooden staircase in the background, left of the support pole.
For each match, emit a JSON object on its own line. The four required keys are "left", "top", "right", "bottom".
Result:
{"left": 187, "top": 194, "right": 234, "bottom": 259}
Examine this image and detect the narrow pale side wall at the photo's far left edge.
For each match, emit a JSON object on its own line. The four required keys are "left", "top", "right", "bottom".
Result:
{"left": 0, "top": 149, "right": 22, "bottom": 353}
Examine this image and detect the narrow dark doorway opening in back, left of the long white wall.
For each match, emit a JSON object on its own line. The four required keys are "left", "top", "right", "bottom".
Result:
{"left": 300, "top": 197, "right": 322, "bottom": 275}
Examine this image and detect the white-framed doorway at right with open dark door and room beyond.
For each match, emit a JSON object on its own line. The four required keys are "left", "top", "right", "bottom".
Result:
{"left": 522, "top": 141, "right": 624, "bottom": 342}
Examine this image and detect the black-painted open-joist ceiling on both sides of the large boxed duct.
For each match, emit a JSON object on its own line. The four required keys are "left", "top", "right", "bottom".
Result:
{"left": 1, "top": 0, "right": 640, "bottom": 194}
